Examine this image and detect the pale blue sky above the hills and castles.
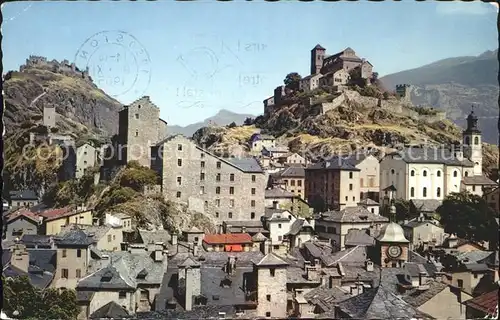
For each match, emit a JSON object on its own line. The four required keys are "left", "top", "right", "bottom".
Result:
{"left": 2, "top": 0, "right": 498, "bottom": 125}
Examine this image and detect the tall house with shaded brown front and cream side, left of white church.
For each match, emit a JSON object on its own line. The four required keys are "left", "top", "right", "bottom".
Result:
{"left": 304, "top": 157, "right": 361, "bottom": 212}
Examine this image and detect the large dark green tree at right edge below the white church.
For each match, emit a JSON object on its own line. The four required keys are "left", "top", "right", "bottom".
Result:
{"left": 436, "top": 192, "right": 498, "bottom": 250}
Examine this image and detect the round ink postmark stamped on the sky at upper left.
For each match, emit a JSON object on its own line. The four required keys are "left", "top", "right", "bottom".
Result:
{"left": 74, "top": 31, "right": 151, "bottom": 100}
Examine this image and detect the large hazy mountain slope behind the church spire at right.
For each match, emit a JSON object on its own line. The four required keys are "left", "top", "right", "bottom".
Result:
{"left": 380, "top": 49, "right": 498, "bottom": 143}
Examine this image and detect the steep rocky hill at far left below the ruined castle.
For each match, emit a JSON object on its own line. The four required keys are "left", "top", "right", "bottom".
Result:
{"left": 3, "top": 60, "right": 121, "bottom": 136}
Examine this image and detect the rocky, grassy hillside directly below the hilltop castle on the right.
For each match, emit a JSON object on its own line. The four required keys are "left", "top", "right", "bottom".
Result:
{"left": 194, "top": 87, "right": 498, "bottom": 178}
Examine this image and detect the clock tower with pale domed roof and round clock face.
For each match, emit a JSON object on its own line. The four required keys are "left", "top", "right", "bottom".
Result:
{"left": 376, "top": 222, "right": 410, "bottom": 268}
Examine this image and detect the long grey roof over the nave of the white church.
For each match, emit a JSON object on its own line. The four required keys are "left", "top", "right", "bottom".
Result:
{"left": 387, "top": 147, "right": 474, "bottom": 167}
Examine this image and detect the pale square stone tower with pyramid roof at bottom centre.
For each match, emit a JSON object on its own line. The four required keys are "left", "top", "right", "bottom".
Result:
{"left": 255, "top": 253, "right": 288, "bottom": 319}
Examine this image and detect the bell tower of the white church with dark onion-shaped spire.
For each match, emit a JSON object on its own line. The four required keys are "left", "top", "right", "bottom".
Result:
{"left": 462, "top": 107, "right": 483, "bottom": 176}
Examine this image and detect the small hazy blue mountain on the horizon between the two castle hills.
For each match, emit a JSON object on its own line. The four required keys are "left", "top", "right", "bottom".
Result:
{"left": 168, "top": 109, "right": 256, "bottom": 137}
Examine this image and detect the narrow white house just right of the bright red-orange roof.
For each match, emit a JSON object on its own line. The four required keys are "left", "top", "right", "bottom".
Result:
{"left": 263, "top": 207, "right": 297, "bottom": 246}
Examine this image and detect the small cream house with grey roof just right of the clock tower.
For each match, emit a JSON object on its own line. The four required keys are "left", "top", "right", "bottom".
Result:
{"left": 403, "top": 217, "right": 446, "bottom": 250}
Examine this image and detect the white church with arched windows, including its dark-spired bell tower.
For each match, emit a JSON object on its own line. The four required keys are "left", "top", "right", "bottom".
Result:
{"left": 380, "top": 110, "right": 496, "bottom": 201}
